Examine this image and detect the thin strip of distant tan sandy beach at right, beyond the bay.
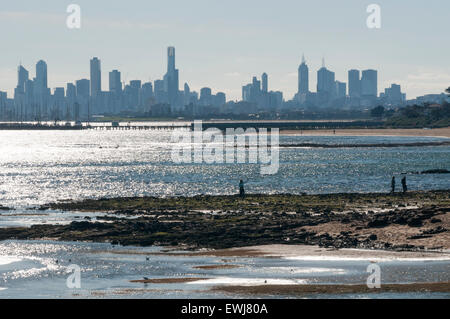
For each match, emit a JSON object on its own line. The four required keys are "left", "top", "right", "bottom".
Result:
{"left": 280, "top": 127, "right": 450, "bottom": 138}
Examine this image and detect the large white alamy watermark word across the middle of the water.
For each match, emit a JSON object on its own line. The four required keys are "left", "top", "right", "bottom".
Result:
{"left": 171, "top": 121, "right": 279, "bottom": 175}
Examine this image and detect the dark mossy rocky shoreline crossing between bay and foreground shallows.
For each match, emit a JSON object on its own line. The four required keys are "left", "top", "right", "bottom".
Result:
{"left": 0, "top": 190, "right": 450, "bottom": 250}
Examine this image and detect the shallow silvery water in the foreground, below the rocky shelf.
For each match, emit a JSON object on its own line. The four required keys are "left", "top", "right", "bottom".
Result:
{"left": 0, "top": 241, "right": 450, "bottom": 298}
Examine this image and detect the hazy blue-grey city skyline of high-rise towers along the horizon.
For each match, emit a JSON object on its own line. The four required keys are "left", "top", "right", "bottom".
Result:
{"left": 0, "top": 46, "right": 447, "bottom": 121}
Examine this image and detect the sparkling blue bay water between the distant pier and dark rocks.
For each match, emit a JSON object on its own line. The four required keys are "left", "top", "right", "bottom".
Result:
{"left": 0, "top": 130, "right": 450, "bottom": 208}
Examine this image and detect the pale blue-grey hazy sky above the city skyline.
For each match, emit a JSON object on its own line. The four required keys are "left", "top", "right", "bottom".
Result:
{"left": 0, "top": 0, "right": 450, "bottom": 100}
